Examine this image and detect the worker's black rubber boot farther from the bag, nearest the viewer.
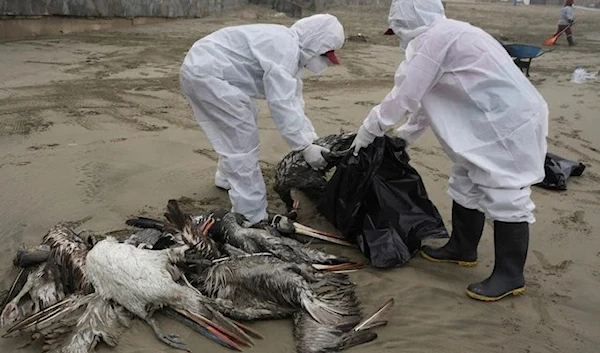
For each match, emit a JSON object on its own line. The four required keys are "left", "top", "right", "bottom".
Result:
{"left": 467, "top": 221, "right": 529, "bottom": 302}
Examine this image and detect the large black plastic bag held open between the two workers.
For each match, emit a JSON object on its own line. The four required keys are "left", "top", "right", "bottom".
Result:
{"left": 317, "top": 136, "right": 448, "bottom": 268}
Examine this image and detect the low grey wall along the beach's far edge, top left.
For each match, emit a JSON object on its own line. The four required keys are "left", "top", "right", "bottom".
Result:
{"left": 0, "top": 0, "right": 248, "bottom": 18}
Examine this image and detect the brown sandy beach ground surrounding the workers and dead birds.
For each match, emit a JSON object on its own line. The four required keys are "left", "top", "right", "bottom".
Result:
{"left": 0, "top": 2, "right": 600, "bottom": 353}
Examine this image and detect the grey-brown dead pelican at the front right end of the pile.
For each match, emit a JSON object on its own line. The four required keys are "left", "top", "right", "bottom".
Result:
{"left": 198, "top": 255, "right": 393, "bottom": 353}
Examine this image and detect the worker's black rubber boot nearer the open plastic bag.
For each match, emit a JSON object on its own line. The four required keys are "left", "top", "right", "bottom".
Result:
{"left": 421, "top": 202, "right": 485, "bottom": 267}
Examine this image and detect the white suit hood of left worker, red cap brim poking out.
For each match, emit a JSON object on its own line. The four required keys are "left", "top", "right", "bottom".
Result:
{"left": 290, "top": 14, "right": 345, "bottom": 74}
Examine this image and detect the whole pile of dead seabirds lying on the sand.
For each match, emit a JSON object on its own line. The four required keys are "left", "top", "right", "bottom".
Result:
{"left": 0, "top": 200, "right": 393, "bottom": 353}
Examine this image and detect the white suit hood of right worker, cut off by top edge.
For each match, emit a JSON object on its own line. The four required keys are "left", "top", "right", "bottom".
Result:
{"left": 385, "top": 0, "right": 446, "bottom": 49}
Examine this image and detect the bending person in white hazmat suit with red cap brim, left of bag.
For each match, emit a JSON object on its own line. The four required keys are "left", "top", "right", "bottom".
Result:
{"left": 180, "top": 14, "right": 345, "bottom": 224}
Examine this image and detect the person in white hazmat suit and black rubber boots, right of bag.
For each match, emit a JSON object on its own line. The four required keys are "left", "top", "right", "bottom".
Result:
{"left": 353, "top": 0, "right": 548, "bottom": 301}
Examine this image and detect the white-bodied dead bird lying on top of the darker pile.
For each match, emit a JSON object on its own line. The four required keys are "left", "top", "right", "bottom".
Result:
{"left": 86, "top": 209, "right": 251, "bottom": 350}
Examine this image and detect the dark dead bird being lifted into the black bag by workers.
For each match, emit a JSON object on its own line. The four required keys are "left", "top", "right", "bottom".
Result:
{"left": 274, "top": 133, "right": 356, "bottom": 219}
